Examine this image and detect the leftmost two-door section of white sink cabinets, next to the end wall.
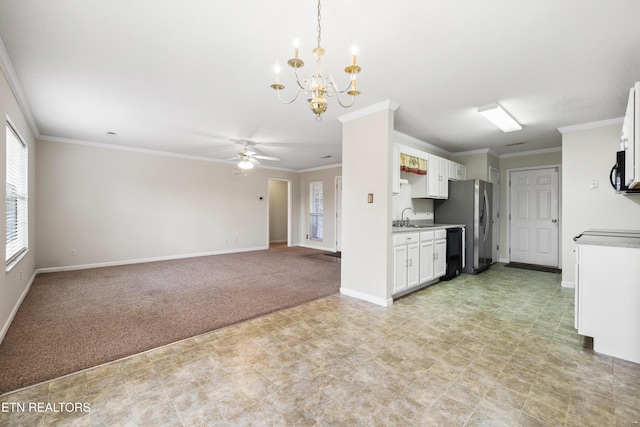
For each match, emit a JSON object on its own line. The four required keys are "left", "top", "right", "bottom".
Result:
{"left": 393, "top": 233, "right": 420, "bottom": 294}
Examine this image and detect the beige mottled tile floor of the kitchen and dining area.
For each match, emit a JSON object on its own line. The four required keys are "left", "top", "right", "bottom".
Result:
{"left": 0, "top": 264, "right": 640, "bottom": 426}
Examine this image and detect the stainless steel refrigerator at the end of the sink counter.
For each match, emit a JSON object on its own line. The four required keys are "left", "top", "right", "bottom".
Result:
{"left": 434, "top": 179, "right": 493, "bottom": 274}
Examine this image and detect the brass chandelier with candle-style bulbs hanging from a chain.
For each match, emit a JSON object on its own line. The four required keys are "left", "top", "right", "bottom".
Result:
{"left": 271, "top": 0, "right": 360, "bottom": 121}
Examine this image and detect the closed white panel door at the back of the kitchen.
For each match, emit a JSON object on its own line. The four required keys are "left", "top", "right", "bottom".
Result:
{"left": 509, "top": 168, "right": 559, "bottom": 267}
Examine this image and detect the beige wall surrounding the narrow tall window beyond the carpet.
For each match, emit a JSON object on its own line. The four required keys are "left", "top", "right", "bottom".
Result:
{"left": 297, "top": 166, "right": 342, "bottom": 251}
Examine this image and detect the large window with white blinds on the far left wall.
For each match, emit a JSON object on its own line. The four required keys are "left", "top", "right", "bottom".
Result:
{"left": 5, "top": 122, "right": 29, "bottom": 265}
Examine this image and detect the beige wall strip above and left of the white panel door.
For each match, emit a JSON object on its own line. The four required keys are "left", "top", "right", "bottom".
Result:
{"left": 498, "top": 150, "right": 562, "bottom": 264}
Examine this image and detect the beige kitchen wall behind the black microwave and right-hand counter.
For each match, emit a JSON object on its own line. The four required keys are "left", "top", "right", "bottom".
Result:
{"left": 562, "top": 125, "right": 640, "bottom": 286}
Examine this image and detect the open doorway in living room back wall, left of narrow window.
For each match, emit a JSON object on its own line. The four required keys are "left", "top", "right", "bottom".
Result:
{"left": 267, "top": 178, "right": 291, "bottom": 246}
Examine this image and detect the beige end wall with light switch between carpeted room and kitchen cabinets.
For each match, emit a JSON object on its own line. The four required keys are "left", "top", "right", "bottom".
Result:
{"left": 340, "top": 103, "right": 394, "bottom": 306}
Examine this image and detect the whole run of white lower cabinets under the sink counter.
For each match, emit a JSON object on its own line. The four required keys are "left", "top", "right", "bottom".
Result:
{"left": 393, "top": 229, "right": 447, "bottom": 294}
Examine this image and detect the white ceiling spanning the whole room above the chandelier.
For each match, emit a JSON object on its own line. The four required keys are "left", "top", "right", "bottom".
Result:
{"left": 0, "top": 0, "right": 640, "bottom": 170}
